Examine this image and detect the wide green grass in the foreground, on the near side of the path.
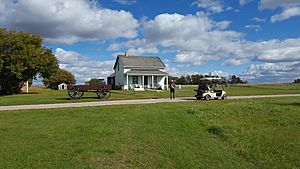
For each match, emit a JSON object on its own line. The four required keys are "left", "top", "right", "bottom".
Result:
{"left": 0, "top": 97, "right": 300, "bottom": 169}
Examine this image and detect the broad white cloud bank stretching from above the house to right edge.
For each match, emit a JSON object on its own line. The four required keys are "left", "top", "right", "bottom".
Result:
{"left": 109, "top": 12, "right": 300, "bottom": 65}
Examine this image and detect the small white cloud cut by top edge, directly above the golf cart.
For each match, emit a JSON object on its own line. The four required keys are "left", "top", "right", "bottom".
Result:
{"left": 193, "top": 0, "right": 224, "bottom": 13}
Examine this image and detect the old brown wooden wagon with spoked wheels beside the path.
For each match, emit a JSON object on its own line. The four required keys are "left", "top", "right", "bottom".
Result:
{"left": 68, "top": 84, "right": 112, "bottom": 99}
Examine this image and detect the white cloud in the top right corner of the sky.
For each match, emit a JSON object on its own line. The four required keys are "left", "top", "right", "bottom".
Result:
{"left": 258, "top": 0, "right": 300, "bottom": 22}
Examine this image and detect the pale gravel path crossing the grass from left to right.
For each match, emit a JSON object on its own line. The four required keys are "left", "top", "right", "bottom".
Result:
{"left": 0, "top": 94, "right": 300, "bottom": 111}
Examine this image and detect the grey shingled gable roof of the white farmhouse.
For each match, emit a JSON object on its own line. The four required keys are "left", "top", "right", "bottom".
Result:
{"left": 114, "top": 55, "right": 166, "bottom": 69}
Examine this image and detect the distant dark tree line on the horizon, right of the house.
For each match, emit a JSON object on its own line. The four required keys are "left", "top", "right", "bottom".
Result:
{"left": 169, "top": 74, "right": 248, "bottom": 85}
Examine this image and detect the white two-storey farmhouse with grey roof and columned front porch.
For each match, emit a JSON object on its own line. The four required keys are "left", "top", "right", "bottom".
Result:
{"left": 107, "top": 53, "right": 168, "bottom": 90}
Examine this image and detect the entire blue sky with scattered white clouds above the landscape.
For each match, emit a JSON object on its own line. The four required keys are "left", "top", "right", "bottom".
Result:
{"left": 0, "top": 0, "right": 300, "bottom": 83}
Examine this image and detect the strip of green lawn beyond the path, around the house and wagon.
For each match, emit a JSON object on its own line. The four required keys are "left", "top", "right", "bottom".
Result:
{"left": 0, "top": 84, "right": 300, "bottom": 106}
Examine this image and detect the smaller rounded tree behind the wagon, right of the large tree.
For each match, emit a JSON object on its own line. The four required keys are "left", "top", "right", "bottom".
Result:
{"left": 43, "top": 69, "right": 76, "bottom": 89}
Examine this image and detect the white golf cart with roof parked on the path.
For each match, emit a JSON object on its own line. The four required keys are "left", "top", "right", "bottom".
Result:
{"left": 195, "top": 77, "right": 227, "bottom": 100}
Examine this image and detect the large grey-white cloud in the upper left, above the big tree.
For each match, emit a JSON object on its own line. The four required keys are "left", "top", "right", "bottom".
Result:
{"left": 0, "top": 0, "right": 138, "bottom": 44}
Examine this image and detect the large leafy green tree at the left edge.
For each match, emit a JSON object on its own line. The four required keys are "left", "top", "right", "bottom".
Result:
{"left": 0, "top": 28, "right": 58, "bottom": 95}
